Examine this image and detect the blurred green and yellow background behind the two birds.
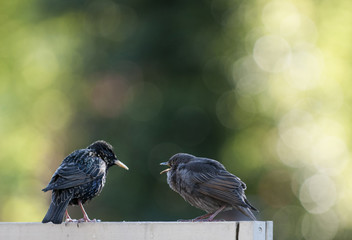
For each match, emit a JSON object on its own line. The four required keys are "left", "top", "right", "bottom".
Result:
{"left": 0, "top": 0, "right": 352, "bottom": 240}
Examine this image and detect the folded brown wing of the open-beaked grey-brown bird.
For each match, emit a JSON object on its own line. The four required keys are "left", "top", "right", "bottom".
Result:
{"left": 187, "top": 162, "right": 249, "bottom": 207}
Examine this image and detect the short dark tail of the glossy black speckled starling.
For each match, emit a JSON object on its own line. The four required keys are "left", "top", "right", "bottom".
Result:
{"left": 42, "top": 191, "right": 71, "bottom": 224}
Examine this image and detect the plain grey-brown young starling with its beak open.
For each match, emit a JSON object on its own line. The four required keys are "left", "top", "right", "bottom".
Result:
{"left": 160, "top": 153, "right": 258, "bottom": 221}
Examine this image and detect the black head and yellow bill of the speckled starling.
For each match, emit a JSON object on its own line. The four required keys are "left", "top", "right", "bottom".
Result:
{"left": 87, "top": 140, "right": 128, "bottom": 170}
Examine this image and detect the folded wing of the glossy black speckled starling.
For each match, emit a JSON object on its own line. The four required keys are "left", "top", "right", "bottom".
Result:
{"left": 43, "top": 151, "right": 105, "bottom": 191}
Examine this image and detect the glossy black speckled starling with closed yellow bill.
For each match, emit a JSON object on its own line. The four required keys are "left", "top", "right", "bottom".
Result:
{"left": 42, "top": 140, "right": 128, "bottom": 224}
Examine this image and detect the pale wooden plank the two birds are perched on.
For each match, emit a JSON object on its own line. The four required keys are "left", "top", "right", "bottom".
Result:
{"left": 0, "top": 221, "right": 272, "bottom": 240}
